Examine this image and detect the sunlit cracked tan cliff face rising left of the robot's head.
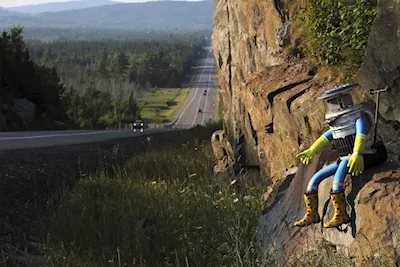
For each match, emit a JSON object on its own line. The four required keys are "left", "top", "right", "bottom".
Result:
{"left": 212, "top": 0, "right": 336, "bottom": 183}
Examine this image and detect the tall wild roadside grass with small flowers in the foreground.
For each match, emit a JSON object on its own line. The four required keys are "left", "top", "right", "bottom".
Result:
{"left": 44, "top": 124, "right": 263, "bottom": 266}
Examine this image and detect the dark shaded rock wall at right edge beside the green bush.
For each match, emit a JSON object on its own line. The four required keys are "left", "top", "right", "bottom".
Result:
{"left": 358, "top": 0, "right": 400, "bottom": 158}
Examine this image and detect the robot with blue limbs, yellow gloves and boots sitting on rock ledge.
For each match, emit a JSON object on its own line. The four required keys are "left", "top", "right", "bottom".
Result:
{"left": 294, "top": 84, "right": 386, "bottom": 228}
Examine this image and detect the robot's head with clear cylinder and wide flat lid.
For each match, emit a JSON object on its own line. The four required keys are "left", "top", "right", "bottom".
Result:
{"left": 317, "top": 84, "right": 361, "bottom": 119}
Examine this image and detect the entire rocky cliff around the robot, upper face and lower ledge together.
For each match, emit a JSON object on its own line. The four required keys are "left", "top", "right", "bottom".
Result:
{"left": 212, "top": 0, "right": 400, "bottom": 263}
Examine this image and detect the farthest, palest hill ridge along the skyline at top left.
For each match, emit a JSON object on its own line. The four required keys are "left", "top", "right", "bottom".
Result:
{"left": 7, "top": 0, "right": 118, "bottom": 14}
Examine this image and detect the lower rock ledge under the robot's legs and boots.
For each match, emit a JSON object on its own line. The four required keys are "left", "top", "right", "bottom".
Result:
{"left": 257, "top": 153, "right": 400, "bottom": 266}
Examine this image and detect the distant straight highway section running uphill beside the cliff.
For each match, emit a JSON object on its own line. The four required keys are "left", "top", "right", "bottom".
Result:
{"left": 173, "top": 47, "right": 217, "bottom": 129}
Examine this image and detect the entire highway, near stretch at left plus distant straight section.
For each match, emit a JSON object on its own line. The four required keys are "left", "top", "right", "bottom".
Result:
{"left": 0, "top": 47, "right": 216, "bottom": 151}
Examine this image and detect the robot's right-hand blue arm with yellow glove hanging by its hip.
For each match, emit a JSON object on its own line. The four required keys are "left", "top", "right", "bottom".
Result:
{"left": 347, "top": 117, "right": 369, "bottom": 176}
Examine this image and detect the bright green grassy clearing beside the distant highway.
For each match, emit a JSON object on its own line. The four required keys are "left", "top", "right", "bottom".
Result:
{"left": 138, "top": 88, "right": 190, "bottom": 123}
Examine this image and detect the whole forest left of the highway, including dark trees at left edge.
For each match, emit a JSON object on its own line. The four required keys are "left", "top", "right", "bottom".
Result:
{"left": 0, "top": 28, "right": 206, "bottom": 129}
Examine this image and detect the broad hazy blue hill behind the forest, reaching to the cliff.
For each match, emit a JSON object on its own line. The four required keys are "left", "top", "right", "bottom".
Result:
{"left": 0, "top": 1, "right": 215, "bottom": 29}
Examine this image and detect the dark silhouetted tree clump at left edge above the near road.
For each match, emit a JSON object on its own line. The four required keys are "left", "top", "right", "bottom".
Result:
{"left": 0, "top": 25, "right": 66, "bottom": 131}
